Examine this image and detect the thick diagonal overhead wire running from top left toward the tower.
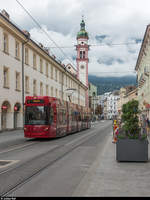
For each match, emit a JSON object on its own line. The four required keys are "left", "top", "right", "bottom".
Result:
{"left": 16, "top": 0, "right": 74, "bottom": 66}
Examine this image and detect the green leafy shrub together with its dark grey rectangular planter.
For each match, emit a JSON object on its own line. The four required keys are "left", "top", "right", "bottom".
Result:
{"left": 116, "top": 100, "right": 148, "bottom": 161}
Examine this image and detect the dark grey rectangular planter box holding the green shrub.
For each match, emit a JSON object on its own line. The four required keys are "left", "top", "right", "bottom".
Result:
{"left": 116, "top": 139, "right": 148, "bottom": 162}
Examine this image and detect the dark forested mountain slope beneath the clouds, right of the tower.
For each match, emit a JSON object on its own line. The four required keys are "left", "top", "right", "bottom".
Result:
{"left": 88, "top": 75, "right": 136, "bottom": 95}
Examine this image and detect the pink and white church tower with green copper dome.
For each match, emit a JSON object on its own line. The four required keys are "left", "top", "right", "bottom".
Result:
{"left": 76, "top": 19, "right": 89, "bottom": 106}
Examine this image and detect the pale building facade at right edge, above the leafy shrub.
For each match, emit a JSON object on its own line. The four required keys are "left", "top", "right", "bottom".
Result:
{"left": 135, "top": 25, "right": 150, "bottom": 117}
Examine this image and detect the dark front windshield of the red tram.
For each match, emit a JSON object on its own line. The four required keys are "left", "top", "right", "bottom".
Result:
{"left": 25, "top": 106, "right": 49, "bottom": 125}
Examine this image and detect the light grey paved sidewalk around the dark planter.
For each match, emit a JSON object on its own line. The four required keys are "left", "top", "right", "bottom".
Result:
{"left": 73, "top": 134, "right": 150, "bottom": 197}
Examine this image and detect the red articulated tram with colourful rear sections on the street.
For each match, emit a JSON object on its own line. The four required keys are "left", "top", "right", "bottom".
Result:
{"left": 24, "top": 96, "right": 91, "bottom": 138}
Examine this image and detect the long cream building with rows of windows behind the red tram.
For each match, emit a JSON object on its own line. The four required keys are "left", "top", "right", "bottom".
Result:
{"left": 0, "top": 10, "right": 87, "bottom": 131}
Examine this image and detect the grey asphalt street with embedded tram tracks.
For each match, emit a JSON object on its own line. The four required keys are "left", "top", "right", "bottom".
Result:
{"left": 0, "top": 121, "right": 112, "bottom": 197}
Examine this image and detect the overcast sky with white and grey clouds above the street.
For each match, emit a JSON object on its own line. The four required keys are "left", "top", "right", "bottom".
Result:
{"left": 1, "top": 0, "right": 150, "bottom": 76}
